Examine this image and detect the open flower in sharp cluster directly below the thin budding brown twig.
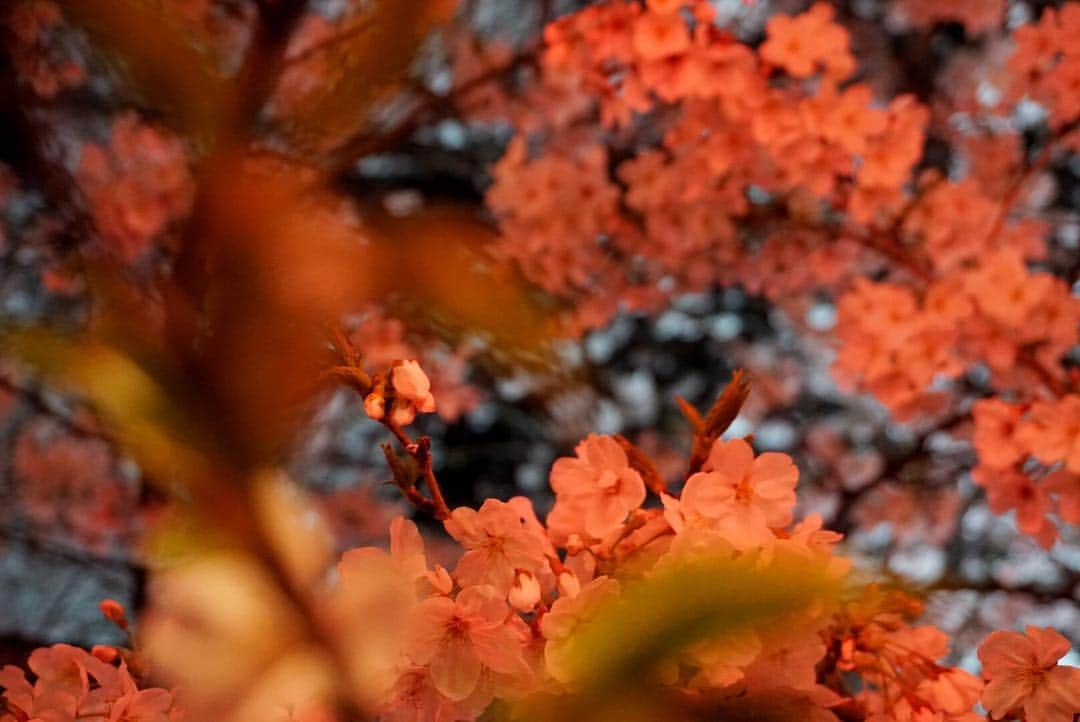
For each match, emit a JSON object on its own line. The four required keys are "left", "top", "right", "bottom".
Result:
{"left": 446, "top": 496, "right": 554, "bottom": 594}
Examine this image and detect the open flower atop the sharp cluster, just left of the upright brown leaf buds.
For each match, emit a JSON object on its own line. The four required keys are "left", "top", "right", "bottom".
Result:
{"left": 548, "top": 434, "right": 645, "bottom": 541}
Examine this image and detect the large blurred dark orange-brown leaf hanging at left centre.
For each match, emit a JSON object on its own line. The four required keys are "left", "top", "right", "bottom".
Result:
{"left": 184, "top": 155, "right": 383, "bottom": 461}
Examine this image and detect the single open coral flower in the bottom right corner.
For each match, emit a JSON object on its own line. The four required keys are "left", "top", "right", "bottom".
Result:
{"left": 978, "top": 626, "right": 1080, "bottom": 722}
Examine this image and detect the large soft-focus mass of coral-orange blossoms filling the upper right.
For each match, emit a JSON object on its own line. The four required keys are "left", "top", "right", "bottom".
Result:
{"left": 475, "top": 0, "right": 1080, "bottom": 545}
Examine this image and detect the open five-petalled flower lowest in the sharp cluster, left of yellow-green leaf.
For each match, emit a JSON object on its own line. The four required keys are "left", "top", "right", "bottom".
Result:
{"left": 405, "top": 586, "right": 529, "bottom": 700}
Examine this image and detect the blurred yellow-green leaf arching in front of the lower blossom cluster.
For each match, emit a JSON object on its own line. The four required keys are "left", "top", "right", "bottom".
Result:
{"left": 523, "top": 555, "right": 842, "bottom": 721}
